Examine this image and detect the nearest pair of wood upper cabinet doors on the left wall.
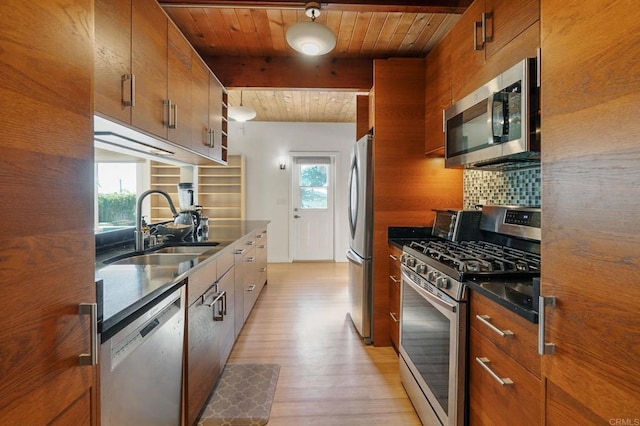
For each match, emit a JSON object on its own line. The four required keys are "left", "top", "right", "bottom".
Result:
{"left": 94, "top": 0, "right": 169, "bottom": 138}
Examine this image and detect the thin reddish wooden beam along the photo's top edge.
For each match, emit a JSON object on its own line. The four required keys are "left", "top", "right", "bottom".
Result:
{"left": 158, "top": 0, "right": 473, "bottom": 14}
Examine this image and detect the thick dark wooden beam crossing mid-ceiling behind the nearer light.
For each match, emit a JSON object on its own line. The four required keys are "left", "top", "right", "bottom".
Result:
{"left": 203, "top": 56, "right": 373, "bottom": 92}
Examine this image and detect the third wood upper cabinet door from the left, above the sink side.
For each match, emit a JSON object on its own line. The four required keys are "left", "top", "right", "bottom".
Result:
{"left": 167, "top": 21, "right": 192, "bottom": 148}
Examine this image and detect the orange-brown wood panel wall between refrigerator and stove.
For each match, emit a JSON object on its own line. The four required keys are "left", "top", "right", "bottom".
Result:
{"left": 373, "top": 59, "right": 462, "bottom": 346}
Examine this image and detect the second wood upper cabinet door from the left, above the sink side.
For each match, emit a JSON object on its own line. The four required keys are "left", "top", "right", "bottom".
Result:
{"left": 131, "top": 0, "right": 168, "bottom": 138}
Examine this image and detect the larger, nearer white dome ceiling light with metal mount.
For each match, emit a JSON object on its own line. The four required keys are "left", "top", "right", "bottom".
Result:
{"left": 287, "top": 2, "right": 336, "bottom": 56}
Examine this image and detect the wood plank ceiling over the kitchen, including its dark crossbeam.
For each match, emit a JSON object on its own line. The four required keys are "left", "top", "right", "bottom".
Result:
{"left": 159, "top": 0, "right": 471, "bottom": 122}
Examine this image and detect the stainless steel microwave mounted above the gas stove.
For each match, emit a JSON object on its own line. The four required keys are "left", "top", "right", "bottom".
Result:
{"left": 444, "top": 58, "right": 540, "bottom": 169}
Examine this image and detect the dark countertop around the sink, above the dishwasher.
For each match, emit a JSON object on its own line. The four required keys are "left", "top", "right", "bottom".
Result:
{"left": 96, "top": 220, "right": 269, "bottom": 340}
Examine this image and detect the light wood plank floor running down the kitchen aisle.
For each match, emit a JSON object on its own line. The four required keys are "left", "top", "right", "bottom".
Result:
{"left": 228, "top": 263, "right": 420, "bottom": 426}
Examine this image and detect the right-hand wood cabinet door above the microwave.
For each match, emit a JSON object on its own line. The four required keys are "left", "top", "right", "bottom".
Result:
{"left": 485, "top": 0, "right": 540, "bottom": 59}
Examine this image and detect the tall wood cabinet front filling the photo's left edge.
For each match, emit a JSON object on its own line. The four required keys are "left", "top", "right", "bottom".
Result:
{"left": 0, "top": 0, "right": 98, "bottom": 425}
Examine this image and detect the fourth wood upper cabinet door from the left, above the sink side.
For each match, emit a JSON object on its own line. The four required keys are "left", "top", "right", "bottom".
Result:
{"left": 191, "top": 52, "right": 212, "bottom": 157}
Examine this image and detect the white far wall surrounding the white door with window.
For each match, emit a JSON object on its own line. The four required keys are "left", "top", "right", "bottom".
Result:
{"left": 229, "top": 121, "right": 356, "bottom": 262}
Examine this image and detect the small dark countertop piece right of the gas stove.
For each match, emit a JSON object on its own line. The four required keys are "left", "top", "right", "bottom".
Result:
{"left": 465, "top": 278, "right": 540, "bottom": 324}
